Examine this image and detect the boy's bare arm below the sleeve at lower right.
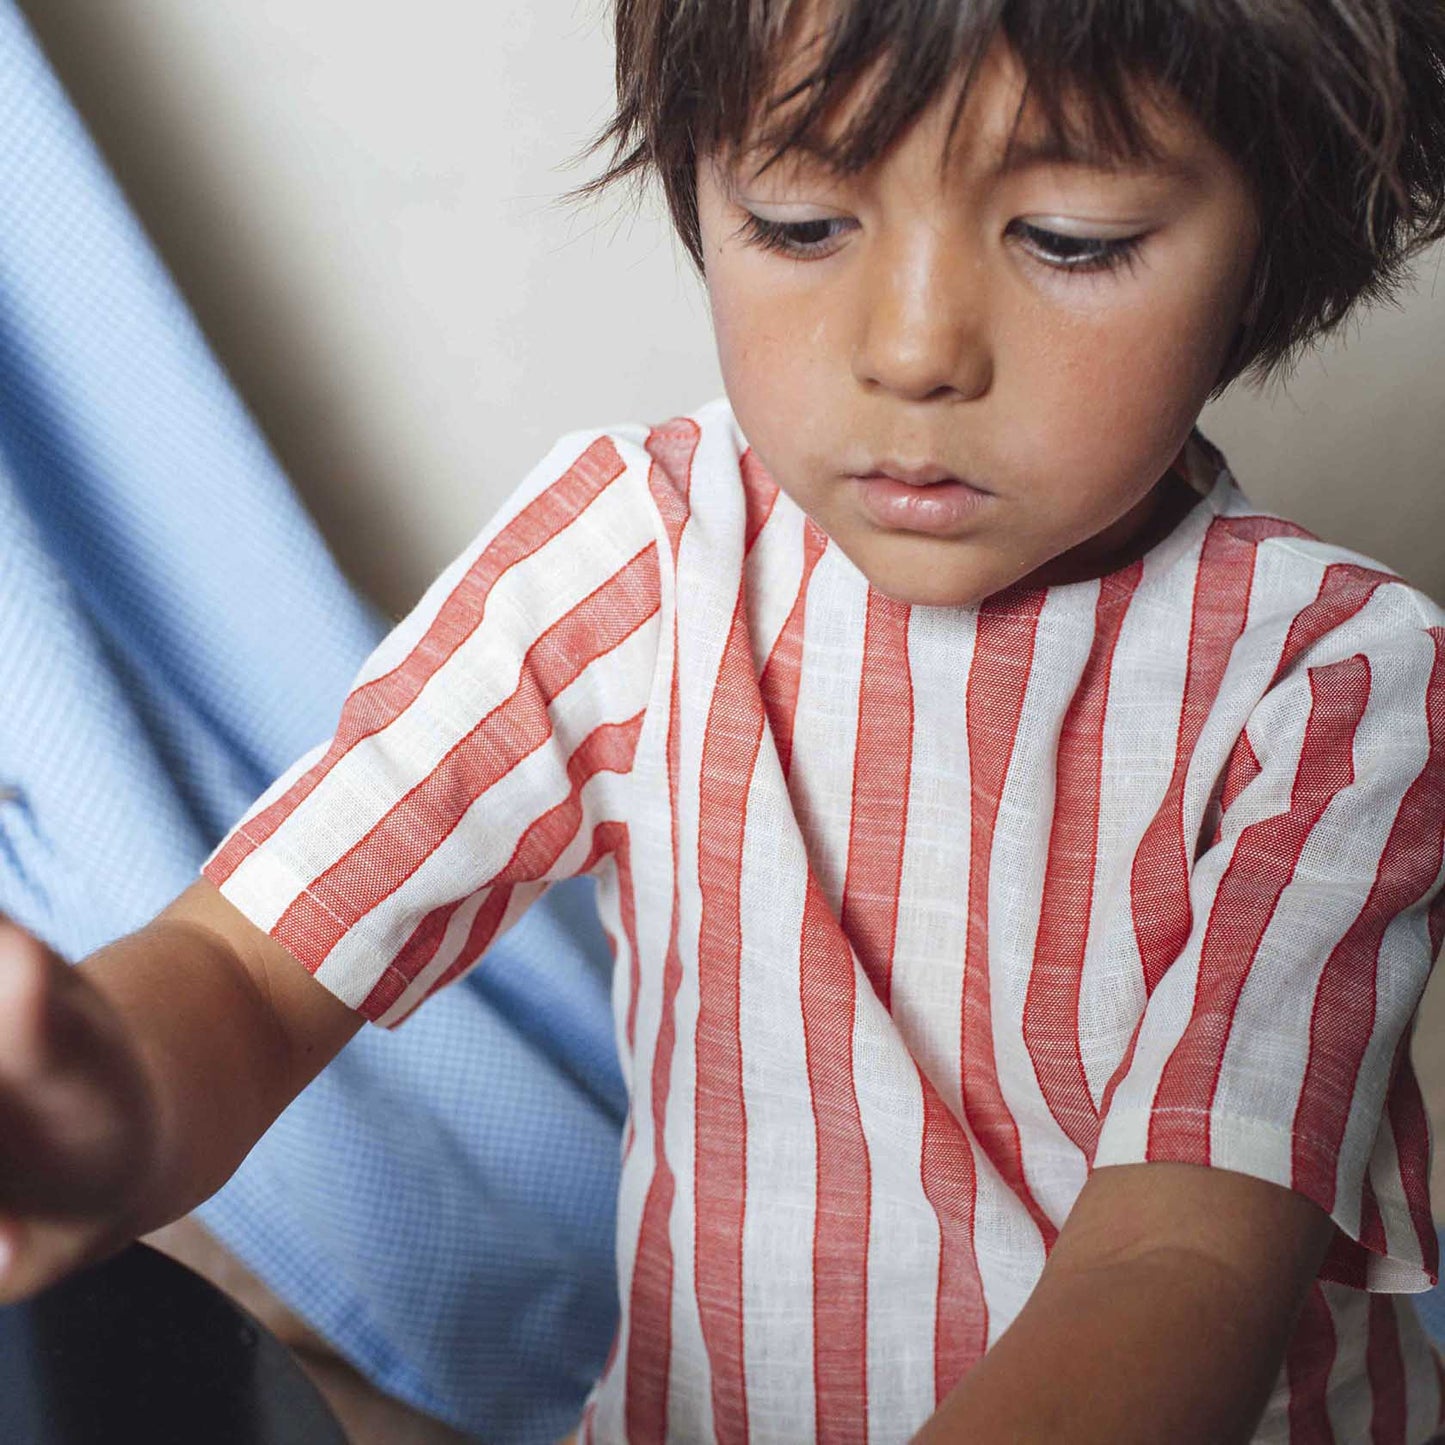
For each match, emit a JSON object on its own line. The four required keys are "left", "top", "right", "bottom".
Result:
{"left": 915, "top": 1162, "right": 1334, "bottom": 1445}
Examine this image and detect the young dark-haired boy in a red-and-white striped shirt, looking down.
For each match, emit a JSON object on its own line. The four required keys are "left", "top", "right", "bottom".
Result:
{"left": 0, "top": 0, "right": 1445, "bottom": 1445}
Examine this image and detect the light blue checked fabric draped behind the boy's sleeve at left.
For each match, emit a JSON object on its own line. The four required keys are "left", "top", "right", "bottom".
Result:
{"left": 0, "top": 0, "right": 624, "bottom": 1445}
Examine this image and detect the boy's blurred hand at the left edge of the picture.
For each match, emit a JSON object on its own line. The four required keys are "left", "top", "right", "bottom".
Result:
{"left": 0, "top": 919, "right": 159, "bottom": 1303}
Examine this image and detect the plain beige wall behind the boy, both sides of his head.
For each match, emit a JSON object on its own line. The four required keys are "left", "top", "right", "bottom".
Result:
{"left": 26, "top": 0, "right": 1445, "bottom": 611}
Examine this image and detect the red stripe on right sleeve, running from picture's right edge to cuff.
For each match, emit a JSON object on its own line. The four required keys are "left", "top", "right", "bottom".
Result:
{"left": 1293, "top": 629, "right": 1445, "bottom": 1208}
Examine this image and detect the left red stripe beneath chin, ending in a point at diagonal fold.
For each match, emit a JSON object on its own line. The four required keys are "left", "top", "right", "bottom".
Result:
{"left": 840, "top": 591, "right": 913, "bottom": 1009}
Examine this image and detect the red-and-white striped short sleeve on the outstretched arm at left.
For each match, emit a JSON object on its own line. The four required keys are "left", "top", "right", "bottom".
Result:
{"left": 204, "top": 435, "right": 660, "bottom": 1026}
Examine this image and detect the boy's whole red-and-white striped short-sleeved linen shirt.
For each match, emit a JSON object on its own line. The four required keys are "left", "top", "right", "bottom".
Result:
{"left": 207, "top": 402, "right": 1445, "bottom": 1445}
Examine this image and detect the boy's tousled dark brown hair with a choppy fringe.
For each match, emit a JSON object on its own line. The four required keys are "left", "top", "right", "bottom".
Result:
{"left": 584, "top": 0, "right": 1445, "bottom": 392}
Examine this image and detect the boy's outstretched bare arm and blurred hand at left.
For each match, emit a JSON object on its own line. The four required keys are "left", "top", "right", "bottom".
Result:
{"left": 0, "top": 880, "right": 361, "bottom": 1303}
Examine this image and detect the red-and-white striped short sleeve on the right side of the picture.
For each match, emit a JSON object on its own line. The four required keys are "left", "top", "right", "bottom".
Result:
{"left": 1094, "top": 604, "right": 1445, "bottom": 1292}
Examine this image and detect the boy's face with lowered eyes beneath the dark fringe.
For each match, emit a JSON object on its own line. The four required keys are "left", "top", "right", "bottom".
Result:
{"left": 698, "top": 39, "right": 1257, "bottom": 605}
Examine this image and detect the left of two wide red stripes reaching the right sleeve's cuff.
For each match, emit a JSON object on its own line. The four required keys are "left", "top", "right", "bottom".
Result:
{"left": 1147, "top": 657, "right": 1370, "bottom": 1165}
